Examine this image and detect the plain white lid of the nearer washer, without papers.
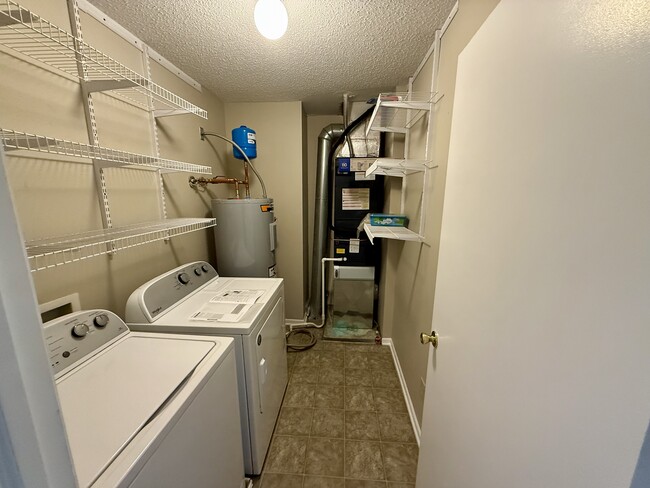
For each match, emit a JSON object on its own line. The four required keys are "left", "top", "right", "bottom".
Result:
{"left": 57, "top": 333, "right": 217, "bottom": 487}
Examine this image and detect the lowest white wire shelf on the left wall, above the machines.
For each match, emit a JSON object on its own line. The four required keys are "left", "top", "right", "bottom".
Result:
{"left": 25, "top": 219, "right": 216, "bottom": 271}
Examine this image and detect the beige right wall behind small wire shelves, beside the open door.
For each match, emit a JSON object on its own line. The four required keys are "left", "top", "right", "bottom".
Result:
{"left": 381, "top": 0, "right": 498, "bottom": 422}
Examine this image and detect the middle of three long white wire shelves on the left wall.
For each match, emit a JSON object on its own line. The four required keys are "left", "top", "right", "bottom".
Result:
{"left": 0, "top": 128, "right": 212, "bottom": 174}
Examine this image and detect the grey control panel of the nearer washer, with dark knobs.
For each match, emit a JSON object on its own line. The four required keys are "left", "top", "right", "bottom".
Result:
{"left": 43, "top": 310, "right": 129, "bottom": 376}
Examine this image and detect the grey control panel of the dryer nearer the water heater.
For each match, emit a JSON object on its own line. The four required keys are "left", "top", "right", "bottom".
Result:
{"left": 142, "top": 261, "right": 219, "bottom": 322}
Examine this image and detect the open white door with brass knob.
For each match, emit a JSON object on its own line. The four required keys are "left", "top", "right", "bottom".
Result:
{"left": 416, "top": 0, "right": 650, "bottom": 488}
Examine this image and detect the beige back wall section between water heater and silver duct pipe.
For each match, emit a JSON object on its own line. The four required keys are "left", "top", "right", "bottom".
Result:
{"left": 225, "top": 102, "right": 307, "bottom": 319}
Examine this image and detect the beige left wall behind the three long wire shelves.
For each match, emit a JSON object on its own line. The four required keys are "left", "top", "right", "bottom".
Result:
{"left": 0, "top": 0, "right": 226, "bottom": 315}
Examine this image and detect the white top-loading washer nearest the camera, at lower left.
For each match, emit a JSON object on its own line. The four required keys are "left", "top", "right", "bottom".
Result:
{"left": 44, "top": 310, "right": 245, "bottom": 488}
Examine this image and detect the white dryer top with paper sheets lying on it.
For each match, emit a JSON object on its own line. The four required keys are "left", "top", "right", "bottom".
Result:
{"left": 140, "top": 278, "right": 283, "bottom": 335}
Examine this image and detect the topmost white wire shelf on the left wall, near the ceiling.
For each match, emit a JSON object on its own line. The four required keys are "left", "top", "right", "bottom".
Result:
{"left": 0, "top": 0, "right": 208, "bottom": 119}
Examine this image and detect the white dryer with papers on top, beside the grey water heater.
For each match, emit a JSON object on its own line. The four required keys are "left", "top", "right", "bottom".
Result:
{"left": 126, "top": 261, "right": 287, "bottom": 475}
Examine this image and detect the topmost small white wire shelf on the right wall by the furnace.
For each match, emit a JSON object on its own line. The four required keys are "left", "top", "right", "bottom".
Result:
{"left": 366, "top": 93, "right": 434, "bottom": 136}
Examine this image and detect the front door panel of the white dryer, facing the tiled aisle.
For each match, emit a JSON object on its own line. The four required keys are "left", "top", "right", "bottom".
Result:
{"left": 255, "top": 297, "right": 288, "bottom": 416}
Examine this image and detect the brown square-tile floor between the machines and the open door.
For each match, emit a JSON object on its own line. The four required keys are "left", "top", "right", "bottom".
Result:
{"left": 255, "top": 331, "right": 418, "bottom": 488}
